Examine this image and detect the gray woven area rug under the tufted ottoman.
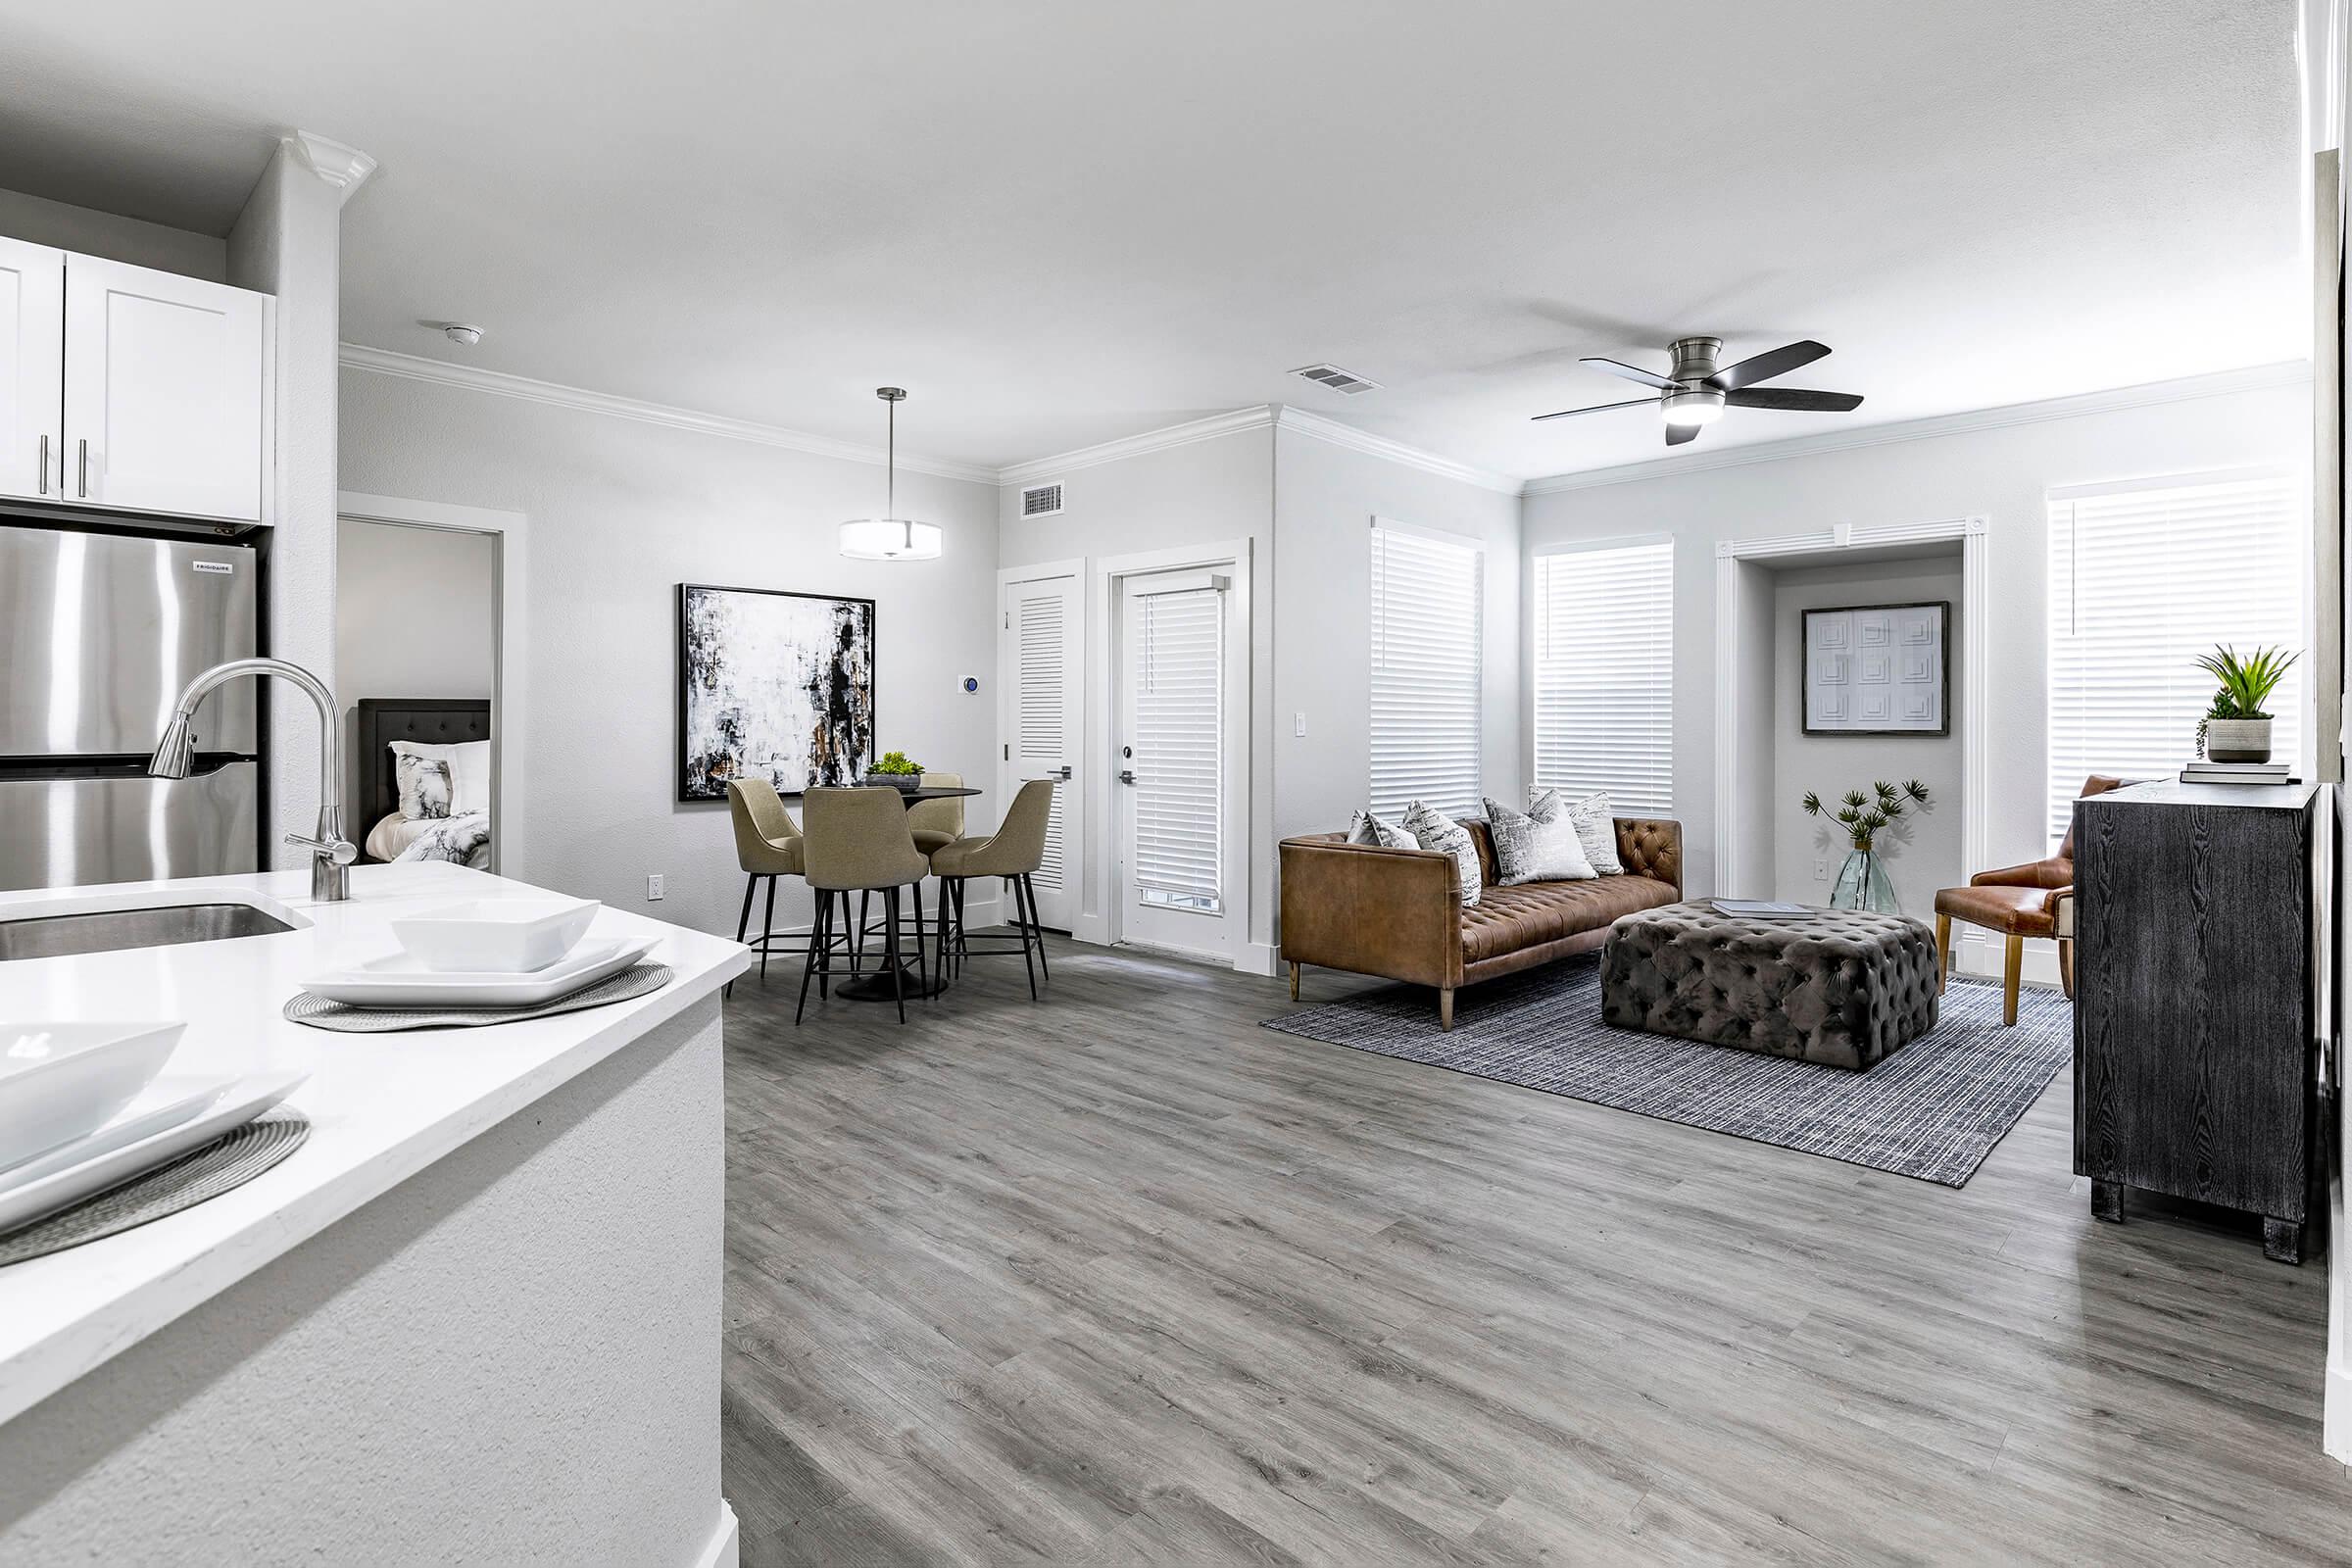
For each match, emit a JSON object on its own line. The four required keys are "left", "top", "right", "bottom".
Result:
{"left": 1265, "top": 956, "right": 2075, "bottom": 1187}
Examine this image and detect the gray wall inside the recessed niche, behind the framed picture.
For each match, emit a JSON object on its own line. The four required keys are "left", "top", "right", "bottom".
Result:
{"left": 1750, "top": 555, "right": 1983, "bottom": 919}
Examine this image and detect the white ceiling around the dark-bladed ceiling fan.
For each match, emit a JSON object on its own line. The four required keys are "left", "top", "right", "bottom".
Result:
{"left": 0, "top": 0, "right": 2307, "bottom": 475}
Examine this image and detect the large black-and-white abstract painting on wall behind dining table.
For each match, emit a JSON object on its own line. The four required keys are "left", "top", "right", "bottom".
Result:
{"left": 677, "top": 583, "right": 875, "bottom": 800}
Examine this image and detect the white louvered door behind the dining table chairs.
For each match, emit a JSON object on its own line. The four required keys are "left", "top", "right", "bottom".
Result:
{"left": 998, "top": 571, "right": 1087, "bottom": 931}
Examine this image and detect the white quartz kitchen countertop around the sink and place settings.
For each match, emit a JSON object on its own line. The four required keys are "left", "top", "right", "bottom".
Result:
{"left": 0, "top": 862, "right": 751, "bottom": 1422}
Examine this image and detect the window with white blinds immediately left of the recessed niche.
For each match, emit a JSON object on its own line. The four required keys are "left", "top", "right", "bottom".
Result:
{"left": 1536, "top": 541, "right": 1675, "bottom": 811}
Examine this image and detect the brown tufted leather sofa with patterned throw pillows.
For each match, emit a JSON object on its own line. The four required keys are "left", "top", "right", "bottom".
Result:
{"left": 1282, "top": 815, "right": 1682, "bottom": 1030}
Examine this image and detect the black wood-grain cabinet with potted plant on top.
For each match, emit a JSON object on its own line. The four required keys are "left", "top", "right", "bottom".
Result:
{"left": 2075, "top": 783, "right": 2327, "bottom": 1262}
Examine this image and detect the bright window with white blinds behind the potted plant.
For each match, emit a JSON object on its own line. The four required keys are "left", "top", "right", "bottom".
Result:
{"left": 2048, "top": 472, "right": 2310, "bottom": 844}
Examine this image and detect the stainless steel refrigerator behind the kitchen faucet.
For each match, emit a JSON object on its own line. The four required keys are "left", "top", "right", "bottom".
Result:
{"left": 0, "top": 526, "right": 261, "bottom": 889}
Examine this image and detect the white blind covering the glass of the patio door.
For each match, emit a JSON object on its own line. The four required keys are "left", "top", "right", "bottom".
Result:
{"left": 1134, "top": 588, "right": 1225, "bottom": 914}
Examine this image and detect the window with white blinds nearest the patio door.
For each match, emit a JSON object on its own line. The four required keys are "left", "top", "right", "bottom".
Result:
{"left": 1371, "top": 524, "right": 1484, "bottom": 815}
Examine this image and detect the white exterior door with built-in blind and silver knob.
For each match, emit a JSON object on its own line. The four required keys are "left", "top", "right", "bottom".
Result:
{"left": 1112, "top": 571, "right": 1240, "bottom": 961}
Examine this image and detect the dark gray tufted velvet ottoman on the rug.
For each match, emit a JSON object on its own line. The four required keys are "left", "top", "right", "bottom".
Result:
{"left": 1601, "top": 901, "right": 1936, "bottom": 1072}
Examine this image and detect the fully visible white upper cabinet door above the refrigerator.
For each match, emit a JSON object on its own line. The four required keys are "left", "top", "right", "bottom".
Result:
{"left": 64, "top": 254, "right": 272, "bottom": 522}
